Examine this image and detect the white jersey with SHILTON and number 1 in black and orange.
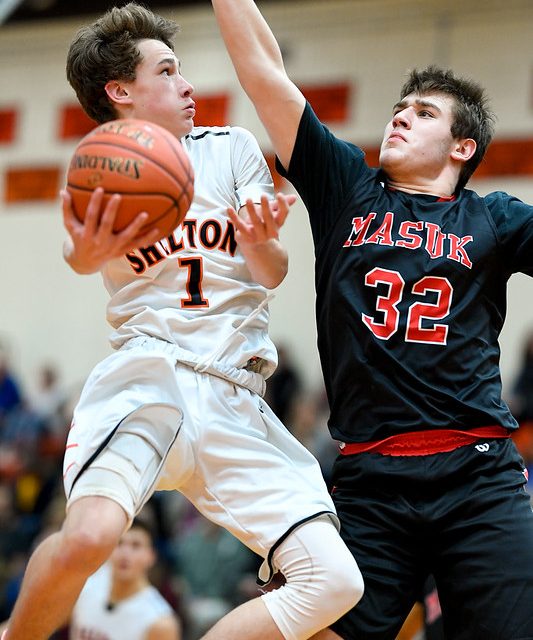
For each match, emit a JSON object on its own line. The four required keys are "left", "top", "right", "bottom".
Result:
{"left": 103, "top": 127, "right": 277, "bottom": 377}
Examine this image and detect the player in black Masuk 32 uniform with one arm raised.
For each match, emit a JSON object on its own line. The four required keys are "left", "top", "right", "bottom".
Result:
{"left": 212, "top": 0, "right": 533, "bottom": 640}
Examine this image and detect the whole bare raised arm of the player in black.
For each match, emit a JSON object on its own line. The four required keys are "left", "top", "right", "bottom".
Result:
{"left": 212, "top": 0, "right": 305, "bottom": 168}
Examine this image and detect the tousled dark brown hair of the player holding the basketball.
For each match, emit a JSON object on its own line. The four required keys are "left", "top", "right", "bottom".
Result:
{"left": 67, "top": 2, "right": 179, "bottom": 123}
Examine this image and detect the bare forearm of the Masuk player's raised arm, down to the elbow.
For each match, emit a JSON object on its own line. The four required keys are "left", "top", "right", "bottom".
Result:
{"left": 212, "top": 0, "right": 285, "bottom": 100}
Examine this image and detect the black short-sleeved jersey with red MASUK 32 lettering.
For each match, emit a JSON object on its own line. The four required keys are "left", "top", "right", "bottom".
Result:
{"left": 278, "top": 105, "right": 533, "bottom": 442}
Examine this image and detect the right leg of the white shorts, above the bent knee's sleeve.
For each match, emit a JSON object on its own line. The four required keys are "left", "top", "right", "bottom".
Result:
{"left": 177, "top": 376, "right": 336, "bottom": 558}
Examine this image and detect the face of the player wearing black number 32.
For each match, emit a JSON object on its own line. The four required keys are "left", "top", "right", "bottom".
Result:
{"left": 379, "top": 93, "right": 456, "bottom": 188}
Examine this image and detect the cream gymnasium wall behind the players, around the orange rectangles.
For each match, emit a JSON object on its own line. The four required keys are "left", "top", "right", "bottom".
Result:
{"left": 0, "top": 0, "right": 533, "bottom": 400}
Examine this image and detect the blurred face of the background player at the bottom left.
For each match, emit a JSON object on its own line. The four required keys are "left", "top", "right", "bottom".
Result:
{"left": 111, "top": 527, "right": 155, "bottom": 582}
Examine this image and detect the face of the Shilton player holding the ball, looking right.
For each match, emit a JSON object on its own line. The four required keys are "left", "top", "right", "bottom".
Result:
{"left": 119, "top": 40, "right": 195, "bottom": 138}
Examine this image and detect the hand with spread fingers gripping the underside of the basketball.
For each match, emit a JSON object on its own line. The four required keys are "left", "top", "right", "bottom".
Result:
{"left": 61, "top": 188, "right": 161, "bottom": 273}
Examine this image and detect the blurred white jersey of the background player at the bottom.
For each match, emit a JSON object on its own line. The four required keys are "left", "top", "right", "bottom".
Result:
{"left": 69, "top": 565, "right": 174, "bottom": 640}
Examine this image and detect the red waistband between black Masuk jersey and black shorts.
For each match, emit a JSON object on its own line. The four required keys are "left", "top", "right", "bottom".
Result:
{"left": 339, "top": 426, "right": 510, "bottom": 456}
